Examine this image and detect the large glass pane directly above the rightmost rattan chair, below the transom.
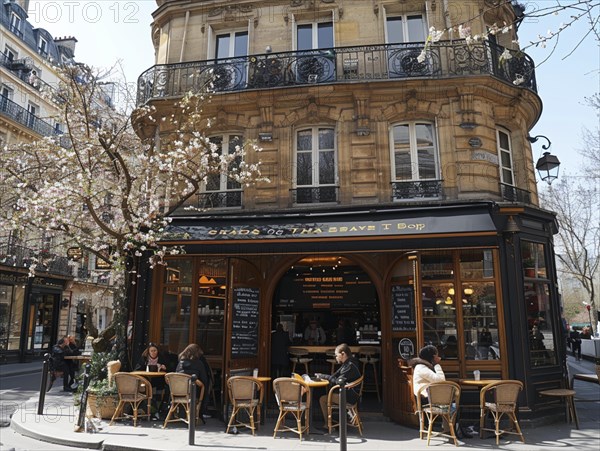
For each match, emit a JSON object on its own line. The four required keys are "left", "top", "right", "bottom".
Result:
{"left": 461, "top": 282, "right": 500, "bottom": 360}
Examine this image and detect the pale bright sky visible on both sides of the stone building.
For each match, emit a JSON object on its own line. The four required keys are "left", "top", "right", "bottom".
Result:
{"left": 29, "top": 0, "right": 600, "bottom": 178}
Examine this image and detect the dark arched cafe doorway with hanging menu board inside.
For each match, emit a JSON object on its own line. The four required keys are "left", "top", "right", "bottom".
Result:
{"left": 271, "top": 255, "right": 382, "bottom": 411}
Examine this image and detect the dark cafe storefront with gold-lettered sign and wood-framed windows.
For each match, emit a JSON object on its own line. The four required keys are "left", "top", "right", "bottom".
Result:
{"left": 132, "top": 202, "right": 564, "bottom": 423}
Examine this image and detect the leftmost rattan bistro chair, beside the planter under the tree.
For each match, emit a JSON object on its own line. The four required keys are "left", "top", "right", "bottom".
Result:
{"left": 109, "top": 372, "right": 152, "bottom": 427}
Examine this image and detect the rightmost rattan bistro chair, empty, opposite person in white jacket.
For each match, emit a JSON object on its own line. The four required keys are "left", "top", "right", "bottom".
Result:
{"left": 479, "top": 380, "right": 525, "bottom": 445}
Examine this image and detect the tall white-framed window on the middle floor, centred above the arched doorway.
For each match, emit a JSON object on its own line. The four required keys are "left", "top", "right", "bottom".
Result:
{"left": 296, "top": 127, "right": 337, "bottom": 203}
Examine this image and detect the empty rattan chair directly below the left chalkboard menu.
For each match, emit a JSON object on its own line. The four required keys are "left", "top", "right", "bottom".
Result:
{"left": 225, "top": 376, "right": 264, "bottom": 435}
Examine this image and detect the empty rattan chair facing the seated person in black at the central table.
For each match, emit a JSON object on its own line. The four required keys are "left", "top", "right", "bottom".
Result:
{"left": 273, "top": 377, "right": 310, "bottom": 441}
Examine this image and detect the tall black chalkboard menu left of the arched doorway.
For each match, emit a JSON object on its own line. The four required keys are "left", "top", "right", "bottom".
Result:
{"left": 231, "top": 288, "right": 259, "bottom": 358}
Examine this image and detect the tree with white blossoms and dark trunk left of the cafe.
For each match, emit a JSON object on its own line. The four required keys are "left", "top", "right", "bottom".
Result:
{"left": 0, "top": 65, "right": 264, "bottom": 358}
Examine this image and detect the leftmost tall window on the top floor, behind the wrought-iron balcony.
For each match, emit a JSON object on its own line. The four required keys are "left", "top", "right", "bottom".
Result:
{"left": 215, "top": 30, "right": 248, "bottom": 91}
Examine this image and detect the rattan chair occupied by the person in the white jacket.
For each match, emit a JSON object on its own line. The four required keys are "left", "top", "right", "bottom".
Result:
{"left": 417, "top": 381, "right": 460, "bottom": 446}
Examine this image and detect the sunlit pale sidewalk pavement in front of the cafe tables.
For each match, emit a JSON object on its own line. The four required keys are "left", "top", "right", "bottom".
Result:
{"left": 0, "top": 357, "right": 600, "bottom": 451}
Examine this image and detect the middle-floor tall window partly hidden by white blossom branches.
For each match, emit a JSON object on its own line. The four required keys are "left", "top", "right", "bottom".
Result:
{"left": 200, "top": 135, "right": 243, "bottom": 208}
